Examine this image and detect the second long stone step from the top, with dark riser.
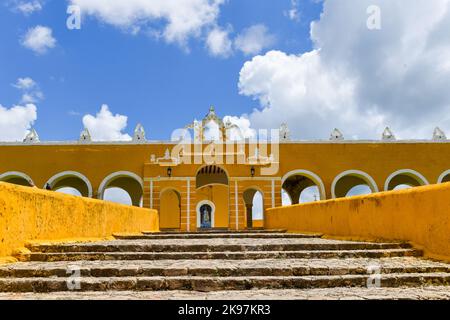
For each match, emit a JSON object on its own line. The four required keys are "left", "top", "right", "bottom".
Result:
{"left": 20, "top": 249, "right": 423, "bottom": 261}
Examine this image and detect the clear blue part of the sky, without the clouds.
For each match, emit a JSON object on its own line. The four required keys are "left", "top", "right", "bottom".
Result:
{"left": 0, "top": 0, "right": 321, "bottom": 140}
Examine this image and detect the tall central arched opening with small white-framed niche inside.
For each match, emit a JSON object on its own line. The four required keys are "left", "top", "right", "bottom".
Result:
{"left": 195, "top": 165, "right": 230, "bottom": 229}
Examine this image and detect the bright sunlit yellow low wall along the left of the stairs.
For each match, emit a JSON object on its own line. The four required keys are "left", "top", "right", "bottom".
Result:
{"left": 0, "top": 182, "right": 159, "bottom": 257}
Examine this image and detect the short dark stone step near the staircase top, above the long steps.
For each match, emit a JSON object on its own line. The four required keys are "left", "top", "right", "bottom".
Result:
{"left": 113, "top": 233, "right": 322, "bottom": 240}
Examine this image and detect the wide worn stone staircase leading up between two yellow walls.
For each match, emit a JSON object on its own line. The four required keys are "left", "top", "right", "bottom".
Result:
{"left": 0, "top": 230, "right": 450, "bottom": 299}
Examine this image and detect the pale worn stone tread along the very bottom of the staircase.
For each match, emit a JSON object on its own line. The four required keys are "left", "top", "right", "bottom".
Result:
{"left": 0, "top": 286, "right": 450, "bottom": 301}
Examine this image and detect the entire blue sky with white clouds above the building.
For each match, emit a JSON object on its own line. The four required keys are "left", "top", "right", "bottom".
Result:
{"left": 0, "top": 0, "right": 450, "bottom": 141}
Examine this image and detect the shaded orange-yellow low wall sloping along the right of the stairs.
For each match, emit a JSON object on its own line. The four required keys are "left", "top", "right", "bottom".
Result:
{"left": 265, "top": 183, "right": 450, "bottom": 261}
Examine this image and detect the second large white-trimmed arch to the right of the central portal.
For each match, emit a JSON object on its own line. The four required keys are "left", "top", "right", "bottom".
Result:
{"left": 331, "top": 170, "right": 378, "bottom": 199}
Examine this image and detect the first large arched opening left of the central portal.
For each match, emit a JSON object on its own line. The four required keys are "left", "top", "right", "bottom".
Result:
{"left": 98, "top": 171, "right": 143, "bottom": 207}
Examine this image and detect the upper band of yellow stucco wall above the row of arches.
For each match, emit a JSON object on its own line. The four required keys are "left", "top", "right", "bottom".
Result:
{"left": 0, "top": 141, "right": 450, "bottom": 201}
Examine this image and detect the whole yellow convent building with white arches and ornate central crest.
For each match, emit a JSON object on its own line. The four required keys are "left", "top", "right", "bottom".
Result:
{"left": 0, "top": 108, "right": 450, "bottom": 231}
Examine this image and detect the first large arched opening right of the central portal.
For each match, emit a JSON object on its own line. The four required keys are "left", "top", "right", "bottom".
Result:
{"left": 282, "top": 170, "right": 326, "bottom": 204}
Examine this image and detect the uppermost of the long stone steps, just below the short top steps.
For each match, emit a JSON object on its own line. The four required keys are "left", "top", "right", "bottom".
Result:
{"left": 28, "top": 240, "right": 411, "bottom": 253}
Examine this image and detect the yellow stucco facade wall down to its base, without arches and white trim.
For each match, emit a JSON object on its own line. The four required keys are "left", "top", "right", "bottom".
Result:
{"left": 0, "top": 141, "right": 450, "bottom": 231}
